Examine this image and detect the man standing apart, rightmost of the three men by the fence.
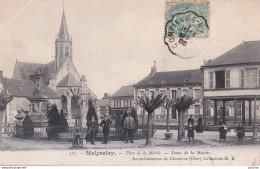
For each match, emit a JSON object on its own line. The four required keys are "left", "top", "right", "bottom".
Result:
{"left": 124, "top": 110, "right": 135, "bottom": 143}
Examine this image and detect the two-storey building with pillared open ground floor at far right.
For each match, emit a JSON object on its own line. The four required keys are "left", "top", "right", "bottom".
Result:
{"left": 201, "top": 41, "right": 260, "bottom": 125}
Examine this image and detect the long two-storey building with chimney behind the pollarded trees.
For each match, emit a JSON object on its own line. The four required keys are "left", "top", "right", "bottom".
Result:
{"left": 135, "top": 64, "right": 203, "bottom": 119}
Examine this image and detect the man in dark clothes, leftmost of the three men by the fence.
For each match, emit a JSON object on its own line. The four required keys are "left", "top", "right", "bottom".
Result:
{"left": 86, "top": 116, "right": 98, "bottom": 144}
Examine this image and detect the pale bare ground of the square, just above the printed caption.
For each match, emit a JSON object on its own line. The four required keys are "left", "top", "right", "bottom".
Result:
{"left": 0, "top": 130, "right": 260, "bottom": 151}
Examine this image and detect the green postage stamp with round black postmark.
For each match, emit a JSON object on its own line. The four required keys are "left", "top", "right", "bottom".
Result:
{"left": 164, "top": 1, "right": 209, "bottom": 59}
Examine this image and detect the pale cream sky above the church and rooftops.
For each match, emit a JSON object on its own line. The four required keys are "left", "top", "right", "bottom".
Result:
{"left": 0, "top": 0, "right": 260, "bottom": 98}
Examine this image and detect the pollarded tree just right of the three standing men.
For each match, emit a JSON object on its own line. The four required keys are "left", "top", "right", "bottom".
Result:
{"left": 137, "top": 94, "right": 166, "bottom": 145}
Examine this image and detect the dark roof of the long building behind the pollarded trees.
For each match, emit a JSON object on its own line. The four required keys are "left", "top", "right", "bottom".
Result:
{"left": 135, "top": 69, "right": 202, "bottom": 87}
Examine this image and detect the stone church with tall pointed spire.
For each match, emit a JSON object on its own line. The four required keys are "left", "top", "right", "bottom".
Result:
{"left": 9, "top": 11, "right": 97, "bottom": 124}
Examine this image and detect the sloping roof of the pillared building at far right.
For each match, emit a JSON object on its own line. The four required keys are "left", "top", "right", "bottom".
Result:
{"left": 201, "top": 41, "right": 260, "bottom": 67}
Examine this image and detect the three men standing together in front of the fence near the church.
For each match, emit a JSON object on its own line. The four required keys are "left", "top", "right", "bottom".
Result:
{"left": 85, "top": 110, "right": 136, "bottom": 144}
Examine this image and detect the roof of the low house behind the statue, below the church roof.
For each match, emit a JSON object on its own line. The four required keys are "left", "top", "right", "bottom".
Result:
{"left": 5, "top": 78, "right": 61, "bottom": 99}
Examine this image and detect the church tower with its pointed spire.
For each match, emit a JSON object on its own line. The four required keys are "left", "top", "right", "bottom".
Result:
{"left": 55, "top": 10, "right": 72, "bottom": 71}
